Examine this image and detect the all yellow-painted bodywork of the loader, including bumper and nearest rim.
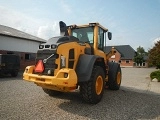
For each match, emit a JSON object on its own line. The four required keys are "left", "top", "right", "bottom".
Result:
{"left": 23, "top": 23, "right": 115, "bottom": 94}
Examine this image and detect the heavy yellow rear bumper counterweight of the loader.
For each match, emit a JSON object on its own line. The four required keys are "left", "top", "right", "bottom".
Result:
{"left": 23, "top": 66, "right": 77, "bottom": 92}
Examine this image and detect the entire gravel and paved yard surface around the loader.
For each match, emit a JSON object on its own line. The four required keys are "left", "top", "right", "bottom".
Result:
{"left": 0, "top": 68, "right": 160, "bottom": 120}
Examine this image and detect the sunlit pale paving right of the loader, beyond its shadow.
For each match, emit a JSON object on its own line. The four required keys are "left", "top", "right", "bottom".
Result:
{"left": 122, "top": 68, "right": 160, "bottom": 94}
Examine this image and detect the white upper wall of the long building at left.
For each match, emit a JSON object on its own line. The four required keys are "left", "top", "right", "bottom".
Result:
{"left": 0, "top": 35, "right": 40, "bottom": 53}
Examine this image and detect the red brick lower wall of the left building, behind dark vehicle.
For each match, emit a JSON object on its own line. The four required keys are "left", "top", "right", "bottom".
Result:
{"left": 0, "top": 50, "right": 36, "bottom": 71}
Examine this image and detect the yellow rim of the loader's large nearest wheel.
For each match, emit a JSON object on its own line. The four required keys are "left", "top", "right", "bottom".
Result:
{"left": 96, "top": 76, "right": 103, "bottom": 95}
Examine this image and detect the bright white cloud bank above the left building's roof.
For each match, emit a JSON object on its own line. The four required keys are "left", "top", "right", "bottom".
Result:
{"left": 0, "top": 6, "right": 59, "bottom": 40}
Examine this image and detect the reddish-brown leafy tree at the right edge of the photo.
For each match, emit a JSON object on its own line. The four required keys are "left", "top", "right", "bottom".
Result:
{"left": 148, "top": 40, "right": 160, "bottom": 69}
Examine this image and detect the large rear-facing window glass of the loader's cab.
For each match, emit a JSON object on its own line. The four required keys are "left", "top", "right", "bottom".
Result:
{"left": 71, "top": 27, "right": 94, "bottom": 43}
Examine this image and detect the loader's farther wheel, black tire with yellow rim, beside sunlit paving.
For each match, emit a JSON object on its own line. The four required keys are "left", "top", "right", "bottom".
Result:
{"left": 107, "top": 62, "right": 122, "bottom": 90}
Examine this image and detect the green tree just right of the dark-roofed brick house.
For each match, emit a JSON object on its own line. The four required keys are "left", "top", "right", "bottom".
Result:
{"left": 134, "top": 46, "right": 147, "bottom": 65}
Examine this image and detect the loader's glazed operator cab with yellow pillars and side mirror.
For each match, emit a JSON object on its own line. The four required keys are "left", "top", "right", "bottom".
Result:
{"left": 68, "top": 23, "right": 112, "bottom": 51}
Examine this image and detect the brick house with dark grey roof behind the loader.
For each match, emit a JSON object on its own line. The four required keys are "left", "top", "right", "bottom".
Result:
{"left": 105, "top": 45, "right": 136, "bottom": 67}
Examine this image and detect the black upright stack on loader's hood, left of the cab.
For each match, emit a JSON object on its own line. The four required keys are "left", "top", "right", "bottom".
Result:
{"left": 59, "top": 21, "right": 69, "bottom": 36}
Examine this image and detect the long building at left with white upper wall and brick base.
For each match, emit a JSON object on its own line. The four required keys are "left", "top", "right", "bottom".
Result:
{"left": 0, "top": 25, "right": 46, "bottom": 70}
